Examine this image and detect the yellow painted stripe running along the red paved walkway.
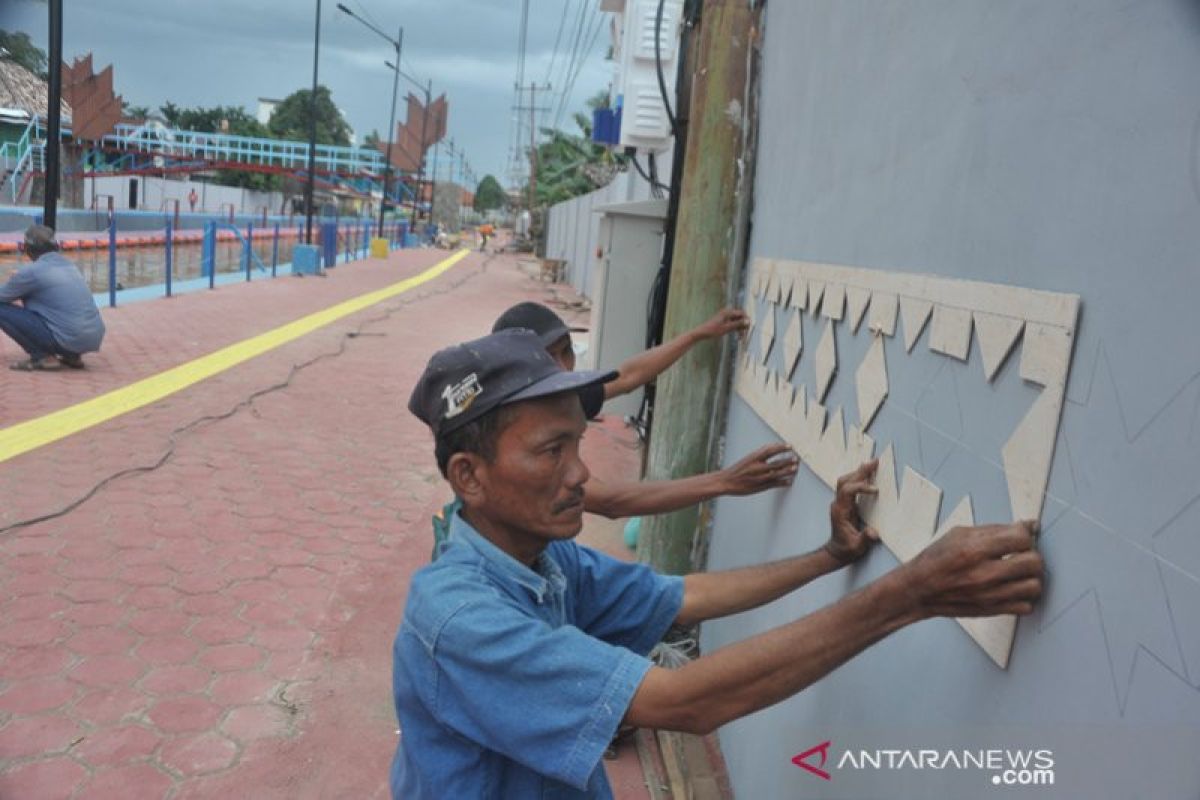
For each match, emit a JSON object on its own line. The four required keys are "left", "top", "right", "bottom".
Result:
{"left": 0, "top": 249, "right": 469, "bottom": 462}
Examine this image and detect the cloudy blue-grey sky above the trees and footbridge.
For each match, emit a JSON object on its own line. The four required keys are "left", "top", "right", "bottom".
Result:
{"left": 0, "top": 0, "right": 612, "bottom": 182}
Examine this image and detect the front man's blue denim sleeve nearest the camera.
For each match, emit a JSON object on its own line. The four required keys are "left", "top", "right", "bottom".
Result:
{"left": 432, "top": 601, "right": 650, "bottom": 790}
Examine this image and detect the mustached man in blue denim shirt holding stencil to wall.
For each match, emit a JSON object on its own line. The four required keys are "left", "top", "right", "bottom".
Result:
{"left": 391, "top": 330, "right": 1043, "bottom": 799}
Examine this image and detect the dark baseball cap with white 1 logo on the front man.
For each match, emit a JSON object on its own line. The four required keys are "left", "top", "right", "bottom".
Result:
{"left": 408, "top": 329, "right": 617, "bottom": 438}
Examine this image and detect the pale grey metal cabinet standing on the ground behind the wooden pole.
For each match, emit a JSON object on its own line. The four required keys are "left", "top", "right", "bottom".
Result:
{"left": 584, "top": 200, "right": 667, "bottom": 416}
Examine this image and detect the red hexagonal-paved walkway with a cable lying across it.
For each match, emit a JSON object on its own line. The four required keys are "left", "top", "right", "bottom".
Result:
{"left": 0, "top": 251, "right": 648, "bottom": 800}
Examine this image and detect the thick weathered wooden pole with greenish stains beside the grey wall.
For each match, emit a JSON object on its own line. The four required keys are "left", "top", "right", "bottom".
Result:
{"left": 638, "top": 0, "right": 762, "bottom": 575}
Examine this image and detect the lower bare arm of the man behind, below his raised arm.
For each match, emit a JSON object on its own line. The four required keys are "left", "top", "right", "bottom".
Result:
{"left": 583, "top": 444, "right": 799, "bottom": 519}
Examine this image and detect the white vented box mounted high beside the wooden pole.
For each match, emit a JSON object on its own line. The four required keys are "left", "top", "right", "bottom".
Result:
{"left": 613, "top": 0, "right": 683, "bottom": 152}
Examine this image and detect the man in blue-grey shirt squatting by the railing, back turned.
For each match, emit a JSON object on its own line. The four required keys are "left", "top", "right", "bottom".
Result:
{"left": 0, "top": 225, "right": 104, "bottom": 371}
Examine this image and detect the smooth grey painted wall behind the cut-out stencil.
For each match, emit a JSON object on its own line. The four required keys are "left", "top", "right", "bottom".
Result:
{"left": 703, "top": 0, "right": 1200, "bottom": 799}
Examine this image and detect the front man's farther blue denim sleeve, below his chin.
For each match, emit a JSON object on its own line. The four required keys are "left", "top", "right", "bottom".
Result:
{"left": 554, "top": 542, "right": 683, "bottom": 655}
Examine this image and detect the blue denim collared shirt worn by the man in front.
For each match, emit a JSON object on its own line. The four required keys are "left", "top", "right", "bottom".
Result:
{"left": 391, "top": 513, "right": 683, "bottom": 800}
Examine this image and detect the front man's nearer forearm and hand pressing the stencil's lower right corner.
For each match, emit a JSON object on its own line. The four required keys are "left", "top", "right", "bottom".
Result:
{"left": 625, "top": 523, "right": 1044, "bottom": 734}
